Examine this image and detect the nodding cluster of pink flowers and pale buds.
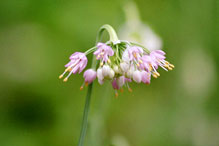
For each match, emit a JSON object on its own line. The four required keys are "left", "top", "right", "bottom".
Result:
{"left": 59, "top": 41, "right": 174, "bottom": 96}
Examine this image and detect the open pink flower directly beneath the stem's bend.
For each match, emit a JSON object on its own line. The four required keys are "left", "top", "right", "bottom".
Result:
{"left": 94, "top": 43, "right": 114, "bottom": 62}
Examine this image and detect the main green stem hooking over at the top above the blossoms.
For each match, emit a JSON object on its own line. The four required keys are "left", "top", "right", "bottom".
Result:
{"left": 78, "top": 24, "right": 118, "bottom": 146}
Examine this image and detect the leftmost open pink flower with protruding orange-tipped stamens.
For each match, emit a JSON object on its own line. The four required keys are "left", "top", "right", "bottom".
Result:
{"left": 59, "top": 52, "right": 87, "bottom": 82}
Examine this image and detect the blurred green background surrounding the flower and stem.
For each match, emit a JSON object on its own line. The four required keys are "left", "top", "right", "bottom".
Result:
{"left": 0, "top": 0, "right": 219, "bottom": 146}
